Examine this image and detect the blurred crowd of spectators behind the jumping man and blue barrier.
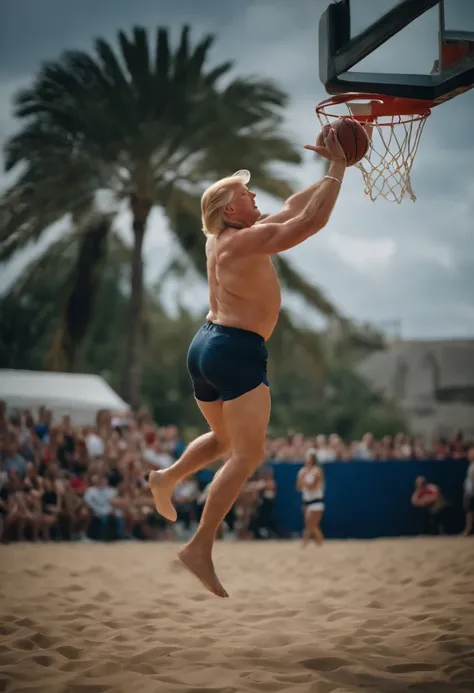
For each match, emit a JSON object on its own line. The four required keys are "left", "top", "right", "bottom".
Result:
{"left": 0, "top": 401, "right": 466, "bottom": 541}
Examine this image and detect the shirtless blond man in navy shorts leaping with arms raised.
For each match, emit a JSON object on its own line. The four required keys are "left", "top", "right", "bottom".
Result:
{"left": 149, "top": 129, "right": 346, "bottom": 597}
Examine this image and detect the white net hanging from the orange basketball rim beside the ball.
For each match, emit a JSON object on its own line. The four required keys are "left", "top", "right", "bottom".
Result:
{"left": 316, "top": 97, "right": 429, "bottom": 203}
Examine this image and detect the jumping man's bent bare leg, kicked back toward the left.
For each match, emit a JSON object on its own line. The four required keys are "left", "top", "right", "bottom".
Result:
{"left": 148, "top": 400, "right": 230, "bottom": 522}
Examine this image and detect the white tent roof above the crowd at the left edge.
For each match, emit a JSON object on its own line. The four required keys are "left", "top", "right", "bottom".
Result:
{"left": 0, "top": 369, "right": 129, "bottom": 425}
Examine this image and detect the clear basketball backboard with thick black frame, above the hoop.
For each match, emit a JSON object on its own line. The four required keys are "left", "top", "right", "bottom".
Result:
{"left": 319, "top": 0, "right": 474, "bottom": 106}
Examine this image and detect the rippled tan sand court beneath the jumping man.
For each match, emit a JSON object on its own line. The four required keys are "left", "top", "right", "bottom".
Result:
{"left": 0, "top": 538, "right": 474, "bottom": 693}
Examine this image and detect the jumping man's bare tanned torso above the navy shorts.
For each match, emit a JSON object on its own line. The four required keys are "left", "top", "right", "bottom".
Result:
{"left": 206, "top": 229, "right": 281, "bottom": 341}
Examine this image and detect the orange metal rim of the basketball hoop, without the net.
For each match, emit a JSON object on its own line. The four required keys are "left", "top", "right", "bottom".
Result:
{"left": 316, "top": 92, "right": 431, "bottom": 126}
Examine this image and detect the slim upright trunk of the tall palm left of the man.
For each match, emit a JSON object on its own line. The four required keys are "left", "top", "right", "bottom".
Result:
{"left": 123, "top": 196, "right": 151, "bottom": 409}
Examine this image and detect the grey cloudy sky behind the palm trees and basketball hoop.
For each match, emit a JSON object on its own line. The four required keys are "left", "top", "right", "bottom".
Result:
{"left": 0, "top": 0, "right": 474, "bottom": 338}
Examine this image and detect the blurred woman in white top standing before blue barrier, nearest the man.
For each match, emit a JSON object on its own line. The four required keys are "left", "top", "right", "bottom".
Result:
{"left": 296, "top": 449, "right": 324, "bottom": 546}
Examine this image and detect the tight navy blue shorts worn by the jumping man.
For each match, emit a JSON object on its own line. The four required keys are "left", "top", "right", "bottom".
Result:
{"left": 188, "top": 322, "right": 268, "bottom": 402}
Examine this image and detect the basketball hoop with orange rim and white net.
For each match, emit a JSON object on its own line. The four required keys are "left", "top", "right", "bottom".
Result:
{"left": 316, "top": 93, "right": 431, "bottom": 203}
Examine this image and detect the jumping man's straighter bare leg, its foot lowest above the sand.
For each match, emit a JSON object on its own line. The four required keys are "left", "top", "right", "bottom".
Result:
{"left": 179, "top": 383, "right": 270, "bottom": 597}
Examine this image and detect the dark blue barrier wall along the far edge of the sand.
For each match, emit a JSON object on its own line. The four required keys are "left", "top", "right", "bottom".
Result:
{"left": 195, "top": 460, "right": 467, "bottom": 539}
